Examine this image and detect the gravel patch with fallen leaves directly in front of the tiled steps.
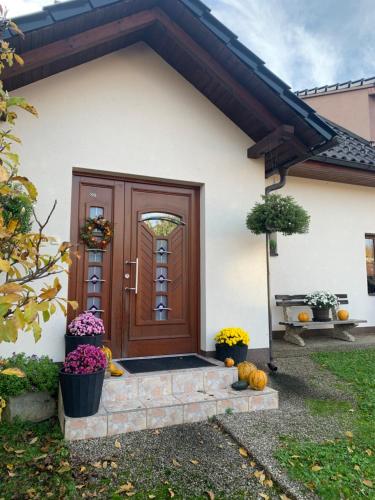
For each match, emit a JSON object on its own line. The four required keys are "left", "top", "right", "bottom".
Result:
{"left": 70, "top": 422, "right": 280, "bottom": 499}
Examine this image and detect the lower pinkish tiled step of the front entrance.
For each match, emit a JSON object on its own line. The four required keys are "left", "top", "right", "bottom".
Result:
{"left": 61, "top": 388, "right": 278, "bottom": 440}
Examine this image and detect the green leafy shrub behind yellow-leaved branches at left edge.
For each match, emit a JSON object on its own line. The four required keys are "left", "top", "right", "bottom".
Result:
{"left": 0, "top": 194, "right": 33, "bottom": 234}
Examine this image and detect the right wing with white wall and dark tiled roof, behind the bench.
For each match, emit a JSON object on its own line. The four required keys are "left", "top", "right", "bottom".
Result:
{"left": 271, "top": 120, "right": 375, "bottom": 330}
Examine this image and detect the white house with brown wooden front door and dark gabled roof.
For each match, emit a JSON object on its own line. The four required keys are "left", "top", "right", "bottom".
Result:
{"left": 1, "top": 0, "right": 338, "bottom": 360}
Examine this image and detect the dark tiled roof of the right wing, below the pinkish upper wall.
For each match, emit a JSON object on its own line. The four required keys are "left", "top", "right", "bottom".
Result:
{"left": 310, "top": 118, "right": 375, "bottom": 172}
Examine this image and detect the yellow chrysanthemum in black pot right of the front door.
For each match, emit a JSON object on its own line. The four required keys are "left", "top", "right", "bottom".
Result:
{"left": 215, "top": 328, "right": 250, "bottom": 364}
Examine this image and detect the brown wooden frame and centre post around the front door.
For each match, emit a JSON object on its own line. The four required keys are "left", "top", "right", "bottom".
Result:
{"left": 68, "top": 171, "right": 201, "bottom": 357}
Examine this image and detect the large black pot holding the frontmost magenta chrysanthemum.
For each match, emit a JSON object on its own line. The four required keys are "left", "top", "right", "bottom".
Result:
{"left": 59, "top": 370, "right": 105, "bottom": 418}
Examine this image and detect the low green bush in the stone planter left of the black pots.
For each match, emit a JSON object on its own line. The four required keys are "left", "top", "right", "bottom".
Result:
{"left": 0, "top": 353, "right": 59, "bottom": 399}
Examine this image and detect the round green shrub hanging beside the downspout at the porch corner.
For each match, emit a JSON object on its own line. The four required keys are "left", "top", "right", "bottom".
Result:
{"left": 246, "top": 194, "right": 310, "bottom": 236}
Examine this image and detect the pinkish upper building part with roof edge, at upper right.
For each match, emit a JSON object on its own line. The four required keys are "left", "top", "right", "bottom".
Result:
{"left": 296, "top": 76, "right": 375, "bottom": 141}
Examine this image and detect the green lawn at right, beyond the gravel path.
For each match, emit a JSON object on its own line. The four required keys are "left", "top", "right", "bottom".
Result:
{"left": 276, "top": 350, "right": 375, "bottom": 500}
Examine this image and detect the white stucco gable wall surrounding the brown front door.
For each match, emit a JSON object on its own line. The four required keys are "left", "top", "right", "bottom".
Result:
{"left": 0, "top": 44, "right": 268, "bottom": 360}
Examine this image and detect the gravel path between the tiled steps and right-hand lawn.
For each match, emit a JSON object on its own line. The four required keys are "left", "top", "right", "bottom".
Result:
{"left": 217, "top": 357, "right": 352, "bottom": 499}
